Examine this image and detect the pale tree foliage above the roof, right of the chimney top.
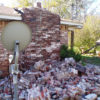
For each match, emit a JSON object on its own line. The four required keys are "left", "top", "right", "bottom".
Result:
{"left": 43, "top": 0, "right": 93, "bottom": 20}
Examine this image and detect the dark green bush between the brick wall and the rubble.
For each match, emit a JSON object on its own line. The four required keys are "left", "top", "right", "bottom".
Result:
{"left": 60, "top": 45, "right": 82, "bottom": 62}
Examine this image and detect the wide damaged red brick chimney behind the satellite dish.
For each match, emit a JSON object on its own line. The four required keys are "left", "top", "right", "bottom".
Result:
{"left": 20, "top": 7, "right": 61, "bottom": 67}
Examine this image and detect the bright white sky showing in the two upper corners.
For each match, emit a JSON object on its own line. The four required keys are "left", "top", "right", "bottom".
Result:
{"left": 0, "top": 0, "right": 100, "bottom": 14}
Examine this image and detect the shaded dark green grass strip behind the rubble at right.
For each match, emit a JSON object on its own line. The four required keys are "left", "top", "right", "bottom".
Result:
{"left": 82, "top": 55, "right": 100, "bottom": 66}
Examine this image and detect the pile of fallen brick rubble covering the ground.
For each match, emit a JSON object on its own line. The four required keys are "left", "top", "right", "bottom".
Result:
{"left": 0, "top": 58, "right": 100, "bottom": 100}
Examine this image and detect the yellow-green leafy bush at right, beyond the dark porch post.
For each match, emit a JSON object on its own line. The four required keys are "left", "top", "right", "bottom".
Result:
{"left": 75, "top": 16, "right": 100, "bottom": 50}
